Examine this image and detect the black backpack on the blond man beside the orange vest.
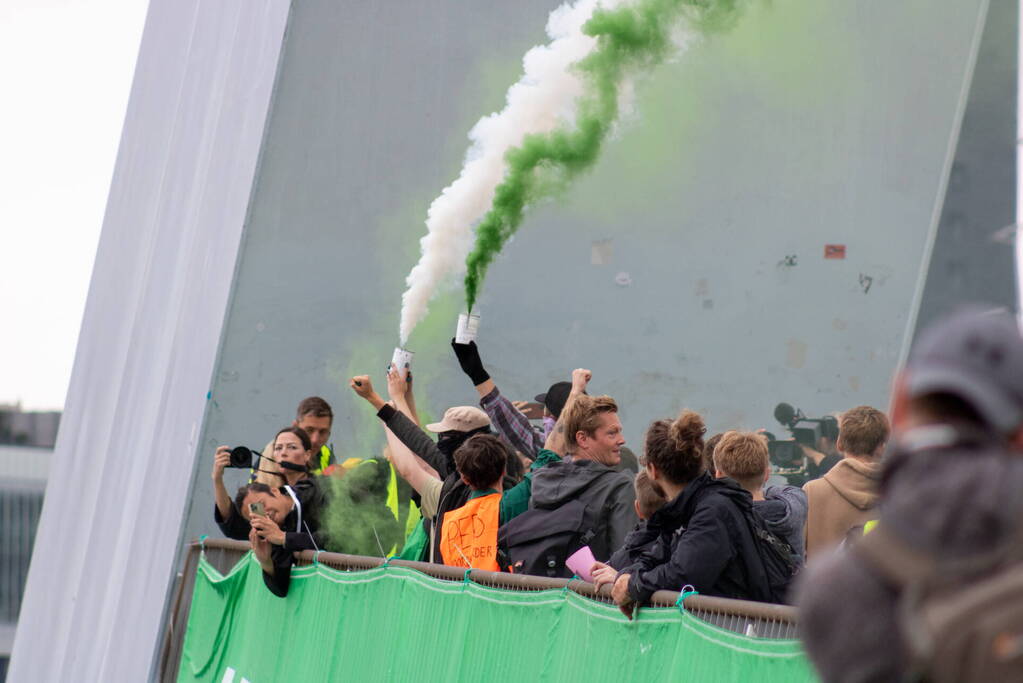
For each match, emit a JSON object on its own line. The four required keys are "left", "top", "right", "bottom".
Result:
{"left": 497, "top": 500, "right": 604, "bottom": 579}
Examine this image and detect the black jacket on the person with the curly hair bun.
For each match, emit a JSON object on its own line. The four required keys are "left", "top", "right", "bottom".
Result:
{"left": 623, "top": 472, "right": 770, "bottom": 602}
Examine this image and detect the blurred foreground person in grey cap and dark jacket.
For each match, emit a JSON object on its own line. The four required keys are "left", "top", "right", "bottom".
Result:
{"left": 797, "top": 311, "right": 1023, "bottom": 682}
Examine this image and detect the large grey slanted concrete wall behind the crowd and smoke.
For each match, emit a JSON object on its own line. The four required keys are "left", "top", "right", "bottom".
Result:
{"left": 184, "top": 0, "right": 998, "bottom": 548}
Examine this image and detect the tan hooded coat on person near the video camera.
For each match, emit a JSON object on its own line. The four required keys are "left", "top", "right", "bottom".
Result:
{"left": 803, "top": 458, "right": 881, "bottom": 559}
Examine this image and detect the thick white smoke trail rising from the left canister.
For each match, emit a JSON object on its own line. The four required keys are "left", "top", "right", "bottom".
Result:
{"left": 400, "top": 0, "right": 628, "bottom": 347}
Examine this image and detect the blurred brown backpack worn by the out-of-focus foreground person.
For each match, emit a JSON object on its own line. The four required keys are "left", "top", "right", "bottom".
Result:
{"left": 850, "top": 525, "right": 1023, "bottom": 683}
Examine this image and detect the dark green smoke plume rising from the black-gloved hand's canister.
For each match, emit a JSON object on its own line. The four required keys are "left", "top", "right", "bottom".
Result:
{"left": 465, "top": 0, "right": 747, "bottom": 311}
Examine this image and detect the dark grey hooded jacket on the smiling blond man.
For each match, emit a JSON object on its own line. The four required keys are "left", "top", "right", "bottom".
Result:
{"left": 529, "top": 460, "right": 638, "bottom": 561}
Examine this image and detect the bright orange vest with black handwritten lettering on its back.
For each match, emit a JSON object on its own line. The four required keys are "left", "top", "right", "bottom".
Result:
{"left": 441, "top": 493, "right": 501, "bottom": 572}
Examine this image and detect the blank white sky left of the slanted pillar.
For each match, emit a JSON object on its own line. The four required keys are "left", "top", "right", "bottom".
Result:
{"left": 0, "top": 0, "right": 148, "bottom": 409}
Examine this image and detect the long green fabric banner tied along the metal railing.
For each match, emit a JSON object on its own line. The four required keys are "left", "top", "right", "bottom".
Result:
{"left": 178, "top": 553, "right": 815, "bottom": 683}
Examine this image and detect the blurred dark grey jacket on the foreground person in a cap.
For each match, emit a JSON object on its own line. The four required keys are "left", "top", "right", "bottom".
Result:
{"left": 797, "top": 425, "right": 1023, "bottom": 683}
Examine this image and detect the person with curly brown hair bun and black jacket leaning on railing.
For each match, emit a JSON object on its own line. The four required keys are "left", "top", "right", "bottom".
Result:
{"left": 593, "top": 410, "right": 770, "bottom": 619}
